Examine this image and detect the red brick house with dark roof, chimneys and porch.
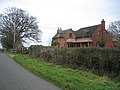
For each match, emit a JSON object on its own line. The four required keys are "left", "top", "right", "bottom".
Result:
{"left": 52, "top": 19, "right": 116, "bottom": 48}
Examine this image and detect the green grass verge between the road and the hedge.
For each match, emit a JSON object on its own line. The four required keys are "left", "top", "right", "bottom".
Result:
{"left": 15, "top": 54, "right": 120, "bottom": 90}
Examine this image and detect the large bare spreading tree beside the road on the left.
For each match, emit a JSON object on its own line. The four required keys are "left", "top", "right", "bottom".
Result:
{"left": 0, "top": 7, "right": 41, "bottom": 47}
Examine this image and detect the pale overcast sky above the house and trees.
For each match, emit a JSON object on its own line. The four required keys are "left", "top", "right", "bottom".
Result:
{"left": 0, "top": 0, "right": 120, "bottom": 45}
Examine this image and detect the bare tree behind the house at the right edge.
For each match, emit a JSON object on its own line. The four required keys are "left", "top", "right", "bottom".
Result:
{"left": 108, "top": 21, "right": 120, "bottom": 46}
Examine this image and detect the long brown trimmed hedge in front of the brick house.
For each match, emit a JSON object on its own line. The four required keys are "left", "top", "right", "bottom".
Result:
{"left": 29, "top": 46, "right": 120, "bottom": 77}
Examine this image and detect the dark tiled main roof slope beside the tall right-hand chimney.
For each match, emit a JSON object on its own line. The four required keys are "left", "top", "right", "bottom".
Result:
{"left": 76, "top": 25, "right": 100, "bottom": 37}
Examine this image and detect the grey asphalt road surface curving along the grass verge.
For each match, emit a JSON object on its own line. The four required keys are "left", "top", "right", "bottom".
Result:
{"left": 0, "top": 54, "right": 60, "bottom": 90}
